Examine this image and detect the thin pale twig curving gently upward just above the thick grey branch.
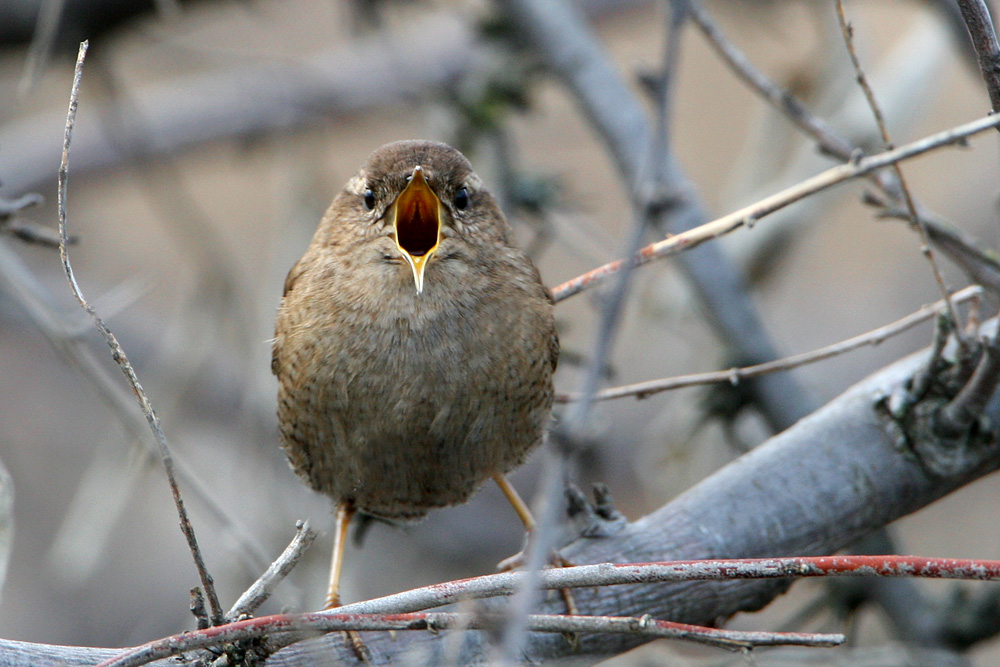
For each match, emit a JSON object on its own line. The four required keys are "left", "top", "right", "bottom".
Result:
{"left": 556, "top": 285, "right": 983, "bottom": 403}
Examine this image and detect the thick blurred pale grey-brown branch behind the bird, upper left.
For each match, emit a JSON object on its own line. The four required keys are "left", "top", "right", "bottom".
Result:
{"left": 0, "top": 15, "right": 483, "bottom": 198}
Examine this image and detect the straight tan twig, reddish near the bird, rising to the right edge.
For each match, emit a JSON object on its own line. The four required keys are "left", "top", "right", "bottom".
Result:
{"left": 552, "top": 114, "right": 1000, "bottom": 302}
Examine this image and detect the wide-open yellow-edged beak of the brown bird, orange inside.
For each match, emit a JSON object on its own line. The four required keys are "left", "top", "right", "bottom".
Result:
{"left": 392, "top": 165, "right": 441, "bottom": 294}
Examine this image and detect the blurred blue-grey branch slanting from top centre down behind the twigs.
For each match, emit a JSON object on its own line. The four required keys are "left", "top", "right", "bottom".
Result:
{"left": 497, "top": 0, "right": 815, "bottom": 431}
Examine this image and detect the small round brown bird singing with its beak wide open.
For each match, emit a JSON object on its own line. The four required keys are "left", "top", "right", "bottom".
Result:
{"left": 271, "top": 141, "right": 559, "bottom": 608}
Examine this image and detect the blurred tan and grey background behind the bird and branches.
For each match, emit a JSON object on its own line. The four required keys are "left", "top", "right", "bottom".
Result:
{"left": 0, "top": 0, "right": 1000, "bottom": 665}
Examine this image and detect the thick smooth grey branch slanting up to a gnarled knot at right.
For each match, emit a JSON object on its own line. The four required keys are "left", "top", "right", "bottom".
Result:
{"left": 0, "top": 322, "right": 1000, "bottom": 665}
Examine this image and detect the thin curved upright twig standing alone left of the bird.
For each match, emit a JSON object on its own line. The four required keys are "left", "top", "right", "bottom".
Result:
{"left": 58, "top": 41, "right": 223, "bottom": 623}
